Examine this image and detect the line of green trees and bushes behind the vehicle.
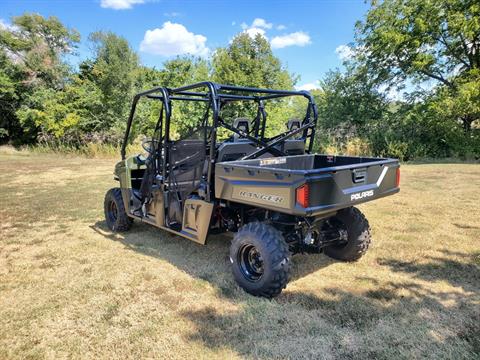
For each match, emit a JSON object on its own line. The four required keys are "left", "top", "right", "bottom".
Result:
{"left": 0, "top": 0, "right": 480, "bottom": 160}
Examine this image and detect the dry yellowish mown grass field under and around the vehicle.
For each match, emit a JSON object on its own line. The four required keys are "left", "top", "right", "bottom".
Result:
{"left": 0, "top": 152, "right": 480, "bottom": 359}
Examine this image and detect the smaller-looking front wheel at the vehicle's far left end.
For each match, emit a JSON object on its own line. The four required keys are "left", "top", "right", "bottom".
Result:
{"left": 103, "top": 188, "right": 133, "bottom": 231}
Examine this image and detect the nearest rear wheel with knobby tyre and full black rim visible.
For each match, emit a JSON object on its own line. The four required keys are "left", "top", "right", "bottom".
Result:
{"left": 230, "top": 222, "right": 290, "bottom": 298}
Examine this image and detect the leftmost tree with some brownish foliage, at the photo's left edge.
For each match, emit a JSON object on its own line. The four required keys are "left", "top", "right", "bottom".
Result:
{"left": 0, "top": 14, "right": 80, "bottom": 142}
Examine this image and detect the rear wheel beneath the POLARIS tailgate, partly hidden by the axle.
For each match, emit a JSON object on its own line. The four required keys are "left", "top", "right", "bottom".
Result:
{"left": 324, "top": 207, "right": 372, "bottom": 261}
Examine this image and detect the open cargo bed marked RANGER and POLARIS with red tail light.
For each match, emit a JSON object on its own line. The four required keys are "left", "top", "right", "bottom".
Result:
{"left": 215, "top": 155, "right": 400, "bottom": 216}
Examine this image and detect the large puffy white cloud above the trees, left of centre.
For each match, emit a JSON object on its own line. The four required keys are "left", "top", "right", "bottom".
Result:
{"left": 140, "top": 21, "right": 209, "bottom": 56}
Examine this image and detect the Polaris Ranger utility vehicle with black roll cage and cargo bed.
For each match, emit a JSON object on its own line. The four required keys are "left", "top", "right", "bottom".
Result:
{"left": 104, "top": 82, "right": 400, "bottom": 298}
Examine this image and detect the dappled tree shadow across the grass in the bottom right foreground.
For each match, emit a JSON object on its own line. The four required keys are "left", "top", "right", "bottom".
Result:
{"left": 177, "top": 253, "right": 480, "bottom": 359}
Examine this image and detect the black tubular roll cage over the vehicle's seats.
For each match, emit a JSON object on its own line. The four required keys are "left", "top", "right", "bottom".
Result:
{"left": 121, "top": 81, "right": 318, "bottom": 201}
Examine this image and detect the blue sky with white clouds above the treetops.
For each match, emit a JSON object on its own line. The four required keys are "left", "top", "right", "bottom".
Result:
{"left": 0, "top": 0, "right": 368, "bottom": 90}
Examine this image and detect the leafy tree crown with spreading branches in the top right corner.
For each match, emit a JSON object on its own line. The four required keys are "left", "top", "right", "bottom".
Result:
{"left": 356, "top": 0, "right": 480, "bottom": 132}
